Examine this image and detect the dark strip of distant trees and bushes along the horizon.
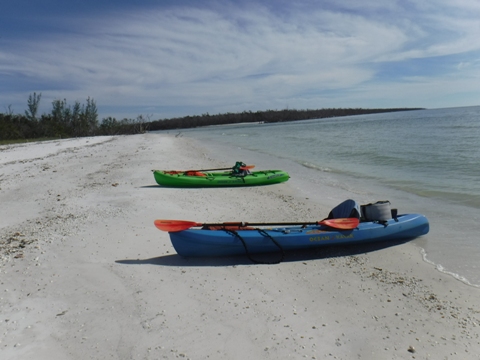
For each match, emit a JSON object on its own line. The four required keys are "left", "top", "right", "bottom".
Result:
{"left": 0, "top": 93, "right": 420, "bottom": 142}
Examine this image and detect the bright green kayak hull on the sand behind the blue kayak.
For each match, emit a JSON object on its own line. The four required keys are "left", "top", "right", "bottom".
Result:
{"left": 153, "top": 170, "right": 290, "bottom": 188}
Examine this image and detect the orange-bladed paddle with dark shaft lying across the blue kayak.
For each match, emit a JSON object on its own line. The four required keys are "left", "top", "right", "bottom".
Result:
{"left": 154, "top": 218, "right": 360, "bottom": 232}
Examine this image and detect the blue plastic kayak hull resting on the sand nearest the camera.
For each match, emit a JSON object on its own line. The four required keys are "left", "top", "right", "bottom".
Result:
{"left": 169, "top": 214, "right": 429, "bottom": 257}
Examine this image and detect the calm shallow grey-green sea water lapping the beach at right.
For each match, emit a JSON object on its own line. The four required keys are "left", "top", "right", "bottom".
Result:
{"left": 159, "top": 106, "right": 480, "bottom": 286}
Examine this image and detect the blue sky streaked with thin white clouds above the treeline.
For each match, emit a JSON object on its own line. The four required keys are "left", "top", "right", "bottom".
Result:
{"left": 0, "top": 0, "right": 480, "bottom": 120}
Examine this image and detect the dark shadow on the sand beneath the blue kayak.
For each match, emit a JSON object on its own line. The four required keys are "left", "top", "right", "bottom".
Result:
{"left": 115, "top": 239, "right": 412, "bottom": 267}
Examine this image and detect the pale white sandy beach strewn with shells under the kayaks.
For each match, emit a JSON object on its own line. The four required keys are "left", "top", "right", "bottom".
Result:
{"left": 0, "top": 134, "right": 480, "bottom": 360}
